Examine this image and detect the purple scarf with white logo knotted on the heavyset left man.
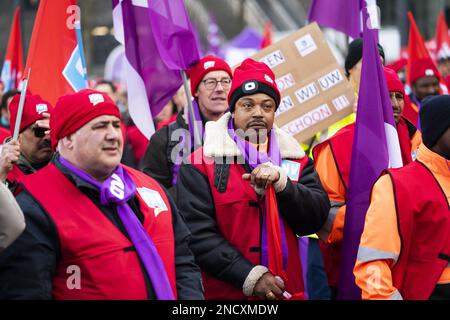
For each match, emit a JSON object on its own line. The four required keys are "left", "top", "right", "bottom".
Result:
{"left": 59, "top": 156, "right": 174, "bottom": 300}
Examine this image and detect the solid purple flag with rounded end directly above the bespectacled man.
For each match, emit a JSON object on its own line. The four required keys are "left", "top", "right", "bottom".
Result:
{"left": 149, "top": 0, "right": 200, "bottom": 71}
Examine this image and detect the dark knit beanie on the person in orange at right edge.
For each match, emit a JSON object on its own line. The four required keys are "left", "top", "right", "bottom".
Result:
{"left": 419, "top": 95, "right": 450, "bottom": 149}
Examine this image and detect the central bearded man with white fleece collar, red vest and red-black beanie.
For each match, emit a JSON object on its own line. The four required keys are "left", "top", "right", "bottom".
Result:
{"left": 177, "top": 59, "right": 329, "bottom": 300}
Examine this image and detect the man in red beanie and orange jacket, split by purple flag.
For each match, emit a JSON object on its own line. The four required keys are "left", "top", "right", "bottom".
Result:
{"left": 313, "top": 68, "right": 422, "bottom": 295}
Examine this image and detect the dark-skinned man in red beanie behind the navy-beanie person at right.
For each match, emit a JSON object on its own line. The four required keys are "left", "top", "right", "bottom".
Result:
{"left": 403, "top": 59, "right": 440, "bottom": 126}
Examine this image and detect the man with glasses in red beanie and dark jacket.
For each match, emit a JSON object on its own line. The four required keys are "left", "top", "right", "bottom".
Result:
{"left": 143, "top": 55, "right": 232, "bottom": 197}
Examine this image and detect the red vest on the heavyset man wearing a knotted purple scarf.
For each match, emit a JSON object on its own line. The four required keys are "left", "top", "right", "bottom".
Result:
{"left": 20, "top": 164, "right": 176, "bottom": 300}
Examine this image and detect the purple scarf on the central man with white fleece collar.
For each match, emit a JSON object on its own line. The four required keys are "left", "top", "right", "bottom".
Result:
{"left": 228, "top": 118, "right": 288, "bottom": 270}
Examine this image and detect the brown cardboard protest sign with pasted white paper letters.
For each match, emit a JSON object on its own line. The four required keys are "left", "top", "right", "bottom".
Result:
{"left": 251, "top": 22, "right": 355, "bottom": 142}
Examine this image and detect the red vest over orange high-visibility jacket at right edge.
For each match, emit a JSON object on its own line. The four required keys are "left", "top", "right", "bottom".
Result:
{"left": 388, "top": 162, "right": 450, "bottom": 300}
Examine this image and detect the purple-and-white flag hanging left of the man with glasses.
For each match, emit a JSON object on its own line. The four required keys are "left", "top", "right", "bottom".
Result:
{"left": 112, "top": 0, "right": 183, "bottom": 138}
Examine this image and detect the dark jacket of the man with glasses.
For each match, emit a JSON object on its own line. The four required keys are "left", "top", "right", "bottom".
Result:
{"left": 142, "top": 112, "right": 205, "bottom": 199}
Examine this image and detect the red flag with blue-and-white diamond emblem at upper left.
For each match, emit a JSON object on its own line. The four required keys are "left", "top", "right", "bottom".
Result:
{"left": 25, "top": 0, "right": 87, "bottom": 105}
